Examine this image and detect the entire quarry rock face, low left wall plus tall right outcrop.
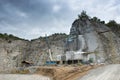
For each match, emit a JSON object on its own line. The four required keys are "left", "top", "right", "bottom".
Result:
{"left": 0, "top": 14, "right": 120, "bottom": 71}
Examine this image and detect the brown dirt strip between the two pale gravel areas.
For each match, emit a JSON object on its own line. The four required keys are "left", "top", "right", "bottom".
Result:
{"left": 34, "top": 65, "right": 102, "bottom": 80}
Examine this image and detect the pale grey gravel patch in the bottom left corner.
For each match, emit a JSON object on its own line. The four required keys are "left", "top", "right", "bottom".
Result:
{"left": 0, "top": 74, "right": 50, "bottom": 80}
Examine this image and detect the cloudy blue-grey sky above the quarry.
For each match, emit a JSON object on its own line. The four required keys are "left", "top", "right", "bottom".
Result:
{"left": 0, "top": 0, "right": 120, "bottom": 40}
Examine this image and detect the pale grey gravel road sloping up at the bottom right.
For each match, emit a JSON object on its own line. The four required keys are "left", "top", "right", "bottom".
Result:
{"left": 77, "top": 64, "right": 120, "bottom": 80}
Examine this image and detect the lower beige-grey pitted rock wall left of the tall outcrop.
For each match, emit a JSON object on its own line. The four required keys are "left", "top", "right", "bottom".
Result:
{"left": 0, "top": 34, "right": 66, "bottom": 72}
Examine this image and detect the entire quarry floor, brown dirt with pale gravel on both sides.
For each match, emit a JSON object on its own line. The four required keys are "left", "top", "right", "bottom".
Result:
{"left": 0, "top": 64, "right": 120, "bottom": 80}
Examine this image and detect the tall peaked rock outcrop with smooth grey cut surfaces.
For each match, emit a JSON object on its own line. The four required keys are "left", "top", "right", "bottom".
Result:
{"left": 70, "top": 11, "right": 120, "bottom": 63}
